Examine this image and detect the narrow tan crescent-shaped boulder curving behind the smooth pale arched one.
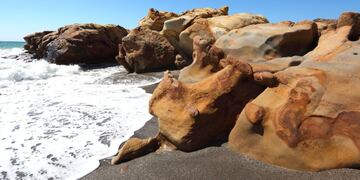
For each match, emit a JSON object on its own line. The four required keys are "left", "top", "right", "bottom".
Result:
{"left": 161, "top": 6, "right": 229, "bottom": 60}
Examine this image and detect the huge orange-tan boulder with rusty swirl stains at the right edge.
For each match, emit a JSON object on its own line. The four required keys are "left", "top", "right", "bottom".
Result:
{"left": 229, "top": 14, "right": 360, "bottom": 171}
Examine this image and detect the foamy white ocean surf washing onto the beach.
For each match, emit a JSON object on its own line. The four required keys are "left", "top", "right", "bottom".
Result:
{"left": 0, "top": 42, "right": 159, "bottom": 179}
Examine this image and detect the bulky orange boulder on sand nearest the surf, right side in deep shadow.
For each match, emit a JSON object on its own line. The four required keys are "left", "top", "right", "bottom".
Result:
{"left": 150, "top": 61, "right": 263, "bottom": 151}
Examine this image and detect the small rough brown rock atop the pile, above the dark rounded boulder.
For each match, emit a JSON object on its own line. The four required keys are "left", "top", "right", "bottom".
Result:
{"left": 139, "top": 8, "right": 178, "bottom": 31}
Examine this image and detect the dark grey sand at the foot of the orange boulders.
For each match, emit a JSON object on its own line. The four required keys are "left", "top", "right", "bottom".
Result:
{"left": 80, "top": 74, "right": 360, "bottom": 180}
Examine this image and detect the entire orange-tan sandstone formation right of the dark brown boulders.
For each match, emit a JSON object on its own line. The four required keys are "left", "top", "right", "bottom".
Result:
{"left": 113, "top": 10, "right": 360, "bottom": 171}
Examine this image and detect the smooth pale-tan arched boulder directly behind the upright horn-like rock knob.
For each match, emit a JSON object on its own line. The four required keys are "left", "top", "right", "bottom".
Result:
{"left": 178, "top": 13, "right": 268, "bottom": 56}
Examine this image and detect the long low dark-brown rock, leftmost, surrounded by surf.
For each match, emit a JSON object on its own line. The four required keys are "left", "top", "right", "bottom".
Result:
{"left": 24, "top": 24, "right": 127, "bottom": 64}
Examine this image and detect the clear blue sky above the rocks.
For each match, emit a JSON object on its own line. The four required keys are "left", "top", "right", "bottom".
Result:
{"left": 0, "top": 0, "right": 360, "bottom": 41}
